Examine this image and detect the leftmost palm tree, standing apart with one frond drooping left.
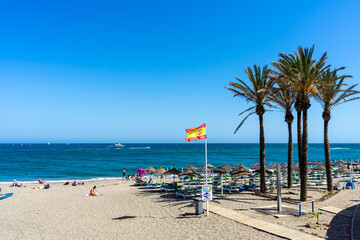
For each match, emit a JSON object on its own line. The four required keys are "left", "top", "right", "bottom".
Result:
{"left": 225, "top": 65, "right": 274, "bottom": 192}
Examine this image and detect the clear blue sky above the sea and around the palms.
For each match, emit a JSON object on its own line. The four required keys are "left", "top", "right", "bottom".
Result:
{"left": 0, "top": 0, "right": 360, "bottom": 143}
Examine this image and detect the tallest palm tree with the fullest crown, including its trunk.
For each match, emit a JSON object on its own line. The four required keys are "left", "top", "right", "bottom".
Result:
{"left": 273, "top": 46, "right": 329, "bottom": 201}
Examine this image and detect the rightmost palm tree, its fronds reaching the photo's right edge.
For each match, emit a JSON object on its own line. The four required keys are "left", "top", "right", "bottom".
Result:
{"left": 314, "top": 67, "right": 360, "bottom": 191}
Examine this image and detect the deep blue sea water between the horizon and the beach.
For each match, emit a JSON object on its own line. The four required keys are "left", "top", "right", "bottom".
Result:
{"left": 0, "top": 143, "right": 360, "bottom": 182}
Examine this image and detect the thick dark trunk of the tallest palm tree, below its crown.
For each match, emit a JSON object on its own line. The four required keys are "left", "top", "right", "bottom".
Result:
{"left": 300, "top": 108, "right": 309, "bottom": 201}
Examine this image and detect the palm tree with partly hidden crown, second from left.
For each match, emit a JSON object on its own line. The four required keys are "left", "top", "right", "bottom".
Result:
{"left": 270, "top": 72, "right": 295, "bottom": 188}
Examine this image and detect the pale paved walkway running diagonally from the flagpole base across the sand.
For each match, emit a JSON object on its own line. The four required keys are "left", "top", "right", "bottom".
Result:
{"left": 209, "top": 204, "right": 323, "bottom": 240}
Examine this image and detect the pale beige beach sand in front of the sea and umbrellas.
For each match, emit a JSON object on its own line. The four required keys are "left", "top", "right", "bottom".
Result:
{"left": 0, "top": 180, "right": 360, "bottom": 239}
